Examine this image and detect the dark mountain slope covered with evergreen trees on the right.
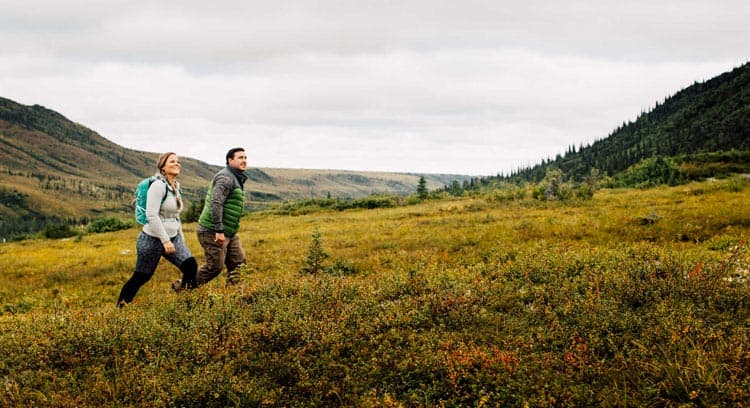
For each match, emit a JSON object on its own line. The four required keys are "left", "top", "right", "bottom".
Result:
{"left": 502, "top": 63, "right": 750, "bottom": 182}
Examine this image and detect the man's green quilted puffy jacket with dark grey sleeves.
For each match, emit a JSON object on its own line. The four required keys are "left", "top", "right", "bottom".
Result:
{"left": 198, "top": 167, "right": 247, "bottom": 237}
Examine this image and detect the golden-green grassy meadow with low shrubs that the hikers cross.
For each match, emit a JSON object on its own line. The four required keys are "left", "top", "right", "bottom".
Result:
{"left": 0, "top": 179, "right": 750, "bottom": 407}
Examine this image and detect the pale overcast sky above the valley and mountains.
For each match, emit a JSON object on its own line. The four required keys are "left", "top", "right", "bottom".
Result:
{"left": 0, "top": 0, "right": 750, "bottom": 175}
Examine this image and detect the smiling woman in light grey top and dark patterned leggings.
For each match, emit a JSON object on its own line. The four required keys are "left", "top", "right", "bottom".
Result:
{"left": 117, "top": 152, "right": 198, "bottom": 307}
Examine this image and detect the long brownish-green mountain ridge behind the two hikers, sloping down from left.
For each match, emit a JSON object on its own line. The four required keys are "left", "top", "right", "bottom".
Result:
{"left": 0, "top": 98, "right": 468, "bottom": 237}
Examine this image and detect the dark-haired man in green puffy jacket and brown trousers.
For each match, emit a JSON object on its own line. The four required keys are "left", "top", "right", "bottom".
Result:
{"left": 197, "top": 147, "right": 247, "bottom": 286}
